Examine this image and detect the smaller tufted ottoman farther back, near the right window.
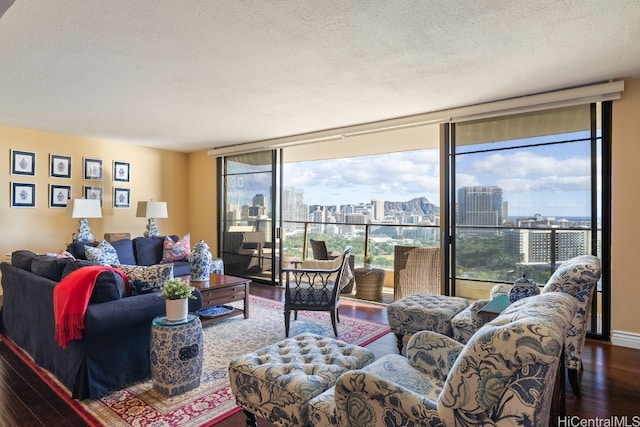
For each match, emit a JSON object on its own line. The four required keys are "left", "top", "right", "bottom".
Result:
{"left": 387, "top": 294, "right": 469, "bottom": 352}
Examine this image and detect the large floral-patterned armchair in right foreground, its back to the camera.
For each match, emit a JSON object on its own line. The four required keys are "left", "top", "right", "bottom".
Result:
{"left": 309, "top": 292, "right": 578, "bottom": 427}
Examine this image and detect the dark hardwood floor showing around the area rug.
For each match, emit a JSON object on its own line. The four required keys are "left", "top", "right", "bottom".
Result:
{"left": 0, "top": 284, "right": 640, "bottom": 427}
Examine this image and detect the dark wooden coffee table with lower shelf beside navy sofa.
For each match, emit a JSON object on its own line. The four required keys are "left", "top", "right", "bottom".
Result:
{"left": 191, "top": 274, "right": 251, "bottom": 325}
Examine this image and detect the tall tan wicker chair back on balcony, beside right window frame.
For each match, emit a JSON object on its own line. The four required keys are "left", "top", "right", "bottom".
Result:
{"left": 393, "top": 246, "right": 442, "bottom": 301}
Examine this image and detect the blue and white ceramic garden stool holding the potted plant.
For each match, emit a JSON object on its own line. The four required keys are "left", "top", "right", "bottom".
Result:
{"left": 151, "top": 314, "right": 203, "bottom": 396}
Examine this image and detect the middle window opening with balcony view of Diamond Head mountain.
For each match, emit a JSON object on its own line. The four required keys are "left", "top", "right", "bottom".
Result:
{"left": 282, "top": 125, "right": 440, "bottom": 274}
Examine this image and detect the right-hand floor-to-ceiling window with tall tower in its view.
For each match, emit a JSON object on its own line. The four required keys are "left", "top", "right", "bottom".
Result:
{"left": 450, "top": 104, "right": 609, "bottom": 342}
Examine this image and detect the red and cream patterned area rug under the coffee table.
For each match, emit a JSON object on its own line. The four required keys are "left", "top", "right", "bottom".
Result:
{"left": 6, "top": 295, "right": 389, "bottom": 427}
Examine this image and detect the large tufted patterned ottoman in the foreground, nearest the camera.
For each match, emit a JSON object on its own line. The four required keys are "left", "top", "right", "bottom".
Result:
{"left": 229, "top": 333, "right": 375, "bottom": 426}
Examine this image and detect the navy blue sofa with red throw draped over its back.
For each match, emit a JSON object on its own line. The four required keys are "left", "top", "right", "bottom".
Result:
{"left": 0, "top": 251, "right": 202, "bottom": 399}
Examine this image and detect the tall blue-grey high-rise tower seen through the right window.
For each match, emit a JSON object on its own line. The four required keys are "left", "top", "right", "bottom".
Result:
{"left": 457, "top": 185, "right": 506, "bottom": 226}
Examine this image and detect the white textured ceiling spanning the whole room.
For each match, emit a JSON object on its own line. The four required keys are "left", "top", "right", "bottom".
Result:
{"left": 0, "top": 0, "right": 640, "bottom": 152}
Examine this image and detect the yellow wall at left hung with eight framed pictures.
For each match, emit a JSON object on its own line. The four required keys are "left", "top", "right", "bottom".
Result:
{"left": 0, "top": 126, "right": 190, "bottom": 260}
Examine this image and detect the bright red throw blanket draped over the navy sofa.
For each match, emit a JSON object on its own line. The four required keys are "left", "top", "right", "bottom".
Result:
{"left": 53, "top": 265, "right": 129, "bottom": 348}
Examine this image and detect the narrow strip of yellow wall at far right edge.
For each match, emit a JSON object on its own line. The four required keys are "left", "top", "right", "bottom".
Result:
{"left": 611, "top": 79, "right": 640, "bottom": 342}
